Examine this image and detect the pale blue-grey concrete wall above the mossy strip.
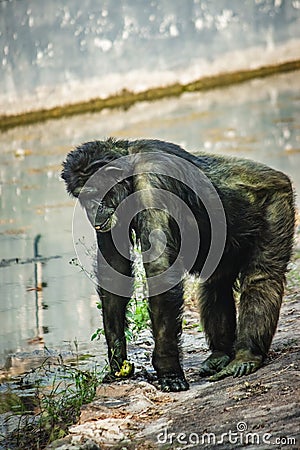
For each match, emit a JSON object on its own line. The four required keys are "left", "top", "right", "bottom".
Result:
{"left": 0, "top": 0, "right": 300, "bottom": 115}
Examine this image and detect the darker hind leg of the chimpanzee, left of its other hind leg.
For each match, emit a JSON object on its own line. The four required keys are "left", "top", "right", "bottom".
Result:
{"left": 199, "top": 277, "right": 236, "bottom": 376}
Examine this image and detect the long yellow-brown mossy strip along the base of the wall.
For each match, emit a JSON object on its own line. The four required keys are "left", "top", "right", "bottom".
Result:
{"left": 0, "top": 60, "right": 300, "bottom": 131}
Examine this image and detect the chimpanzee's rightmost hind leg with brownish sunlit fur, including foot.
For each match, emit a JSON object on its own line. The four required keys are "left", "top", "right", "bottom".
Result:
{"left": 210, "top": 185, "right": 294, "bottom": 381}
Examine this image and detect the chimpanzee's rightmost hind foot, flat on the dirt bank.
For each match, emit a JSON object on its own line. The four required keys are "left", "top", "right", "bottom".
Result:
{"left": 209, "top": 351, "right": 263, "bottom": 381}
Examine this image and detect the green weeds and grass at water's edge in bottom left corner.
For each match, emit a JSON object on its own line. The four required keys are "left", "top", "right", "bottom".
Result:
{"left": 1, "top": 358, "right": 104, "bottom": 450}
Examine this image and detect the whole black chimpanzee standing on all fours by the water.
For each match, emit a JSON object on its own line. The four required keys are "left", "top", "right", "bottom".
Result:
{"left": 62, "top": 138, "right": 295, "bottom": 391}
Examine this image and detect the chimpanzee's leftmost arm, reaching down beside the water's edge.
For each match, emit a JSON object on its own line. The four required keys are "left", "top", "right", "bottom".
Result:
{"left": 97, "top": 232, "right": 133, "bottom": 382}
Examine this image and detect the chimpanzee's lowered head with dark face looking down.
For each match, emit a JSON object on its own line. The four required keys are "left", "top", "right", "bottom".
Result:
{"left": 62, "top": 139, "right": 131, "bottom": 232}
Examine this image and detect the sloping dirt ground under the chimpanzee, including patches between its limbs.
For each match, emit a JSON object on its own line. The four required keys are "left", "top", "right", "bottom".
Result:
{"left": 48, "top": 237, "right": 300, "bottom": 450}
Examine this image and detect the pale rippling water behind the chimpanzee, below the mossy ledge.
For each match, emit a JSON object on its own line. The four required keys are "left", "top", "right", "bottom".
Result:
{"left": 0, "top": 69, "right": 300, "bottom": 372}
